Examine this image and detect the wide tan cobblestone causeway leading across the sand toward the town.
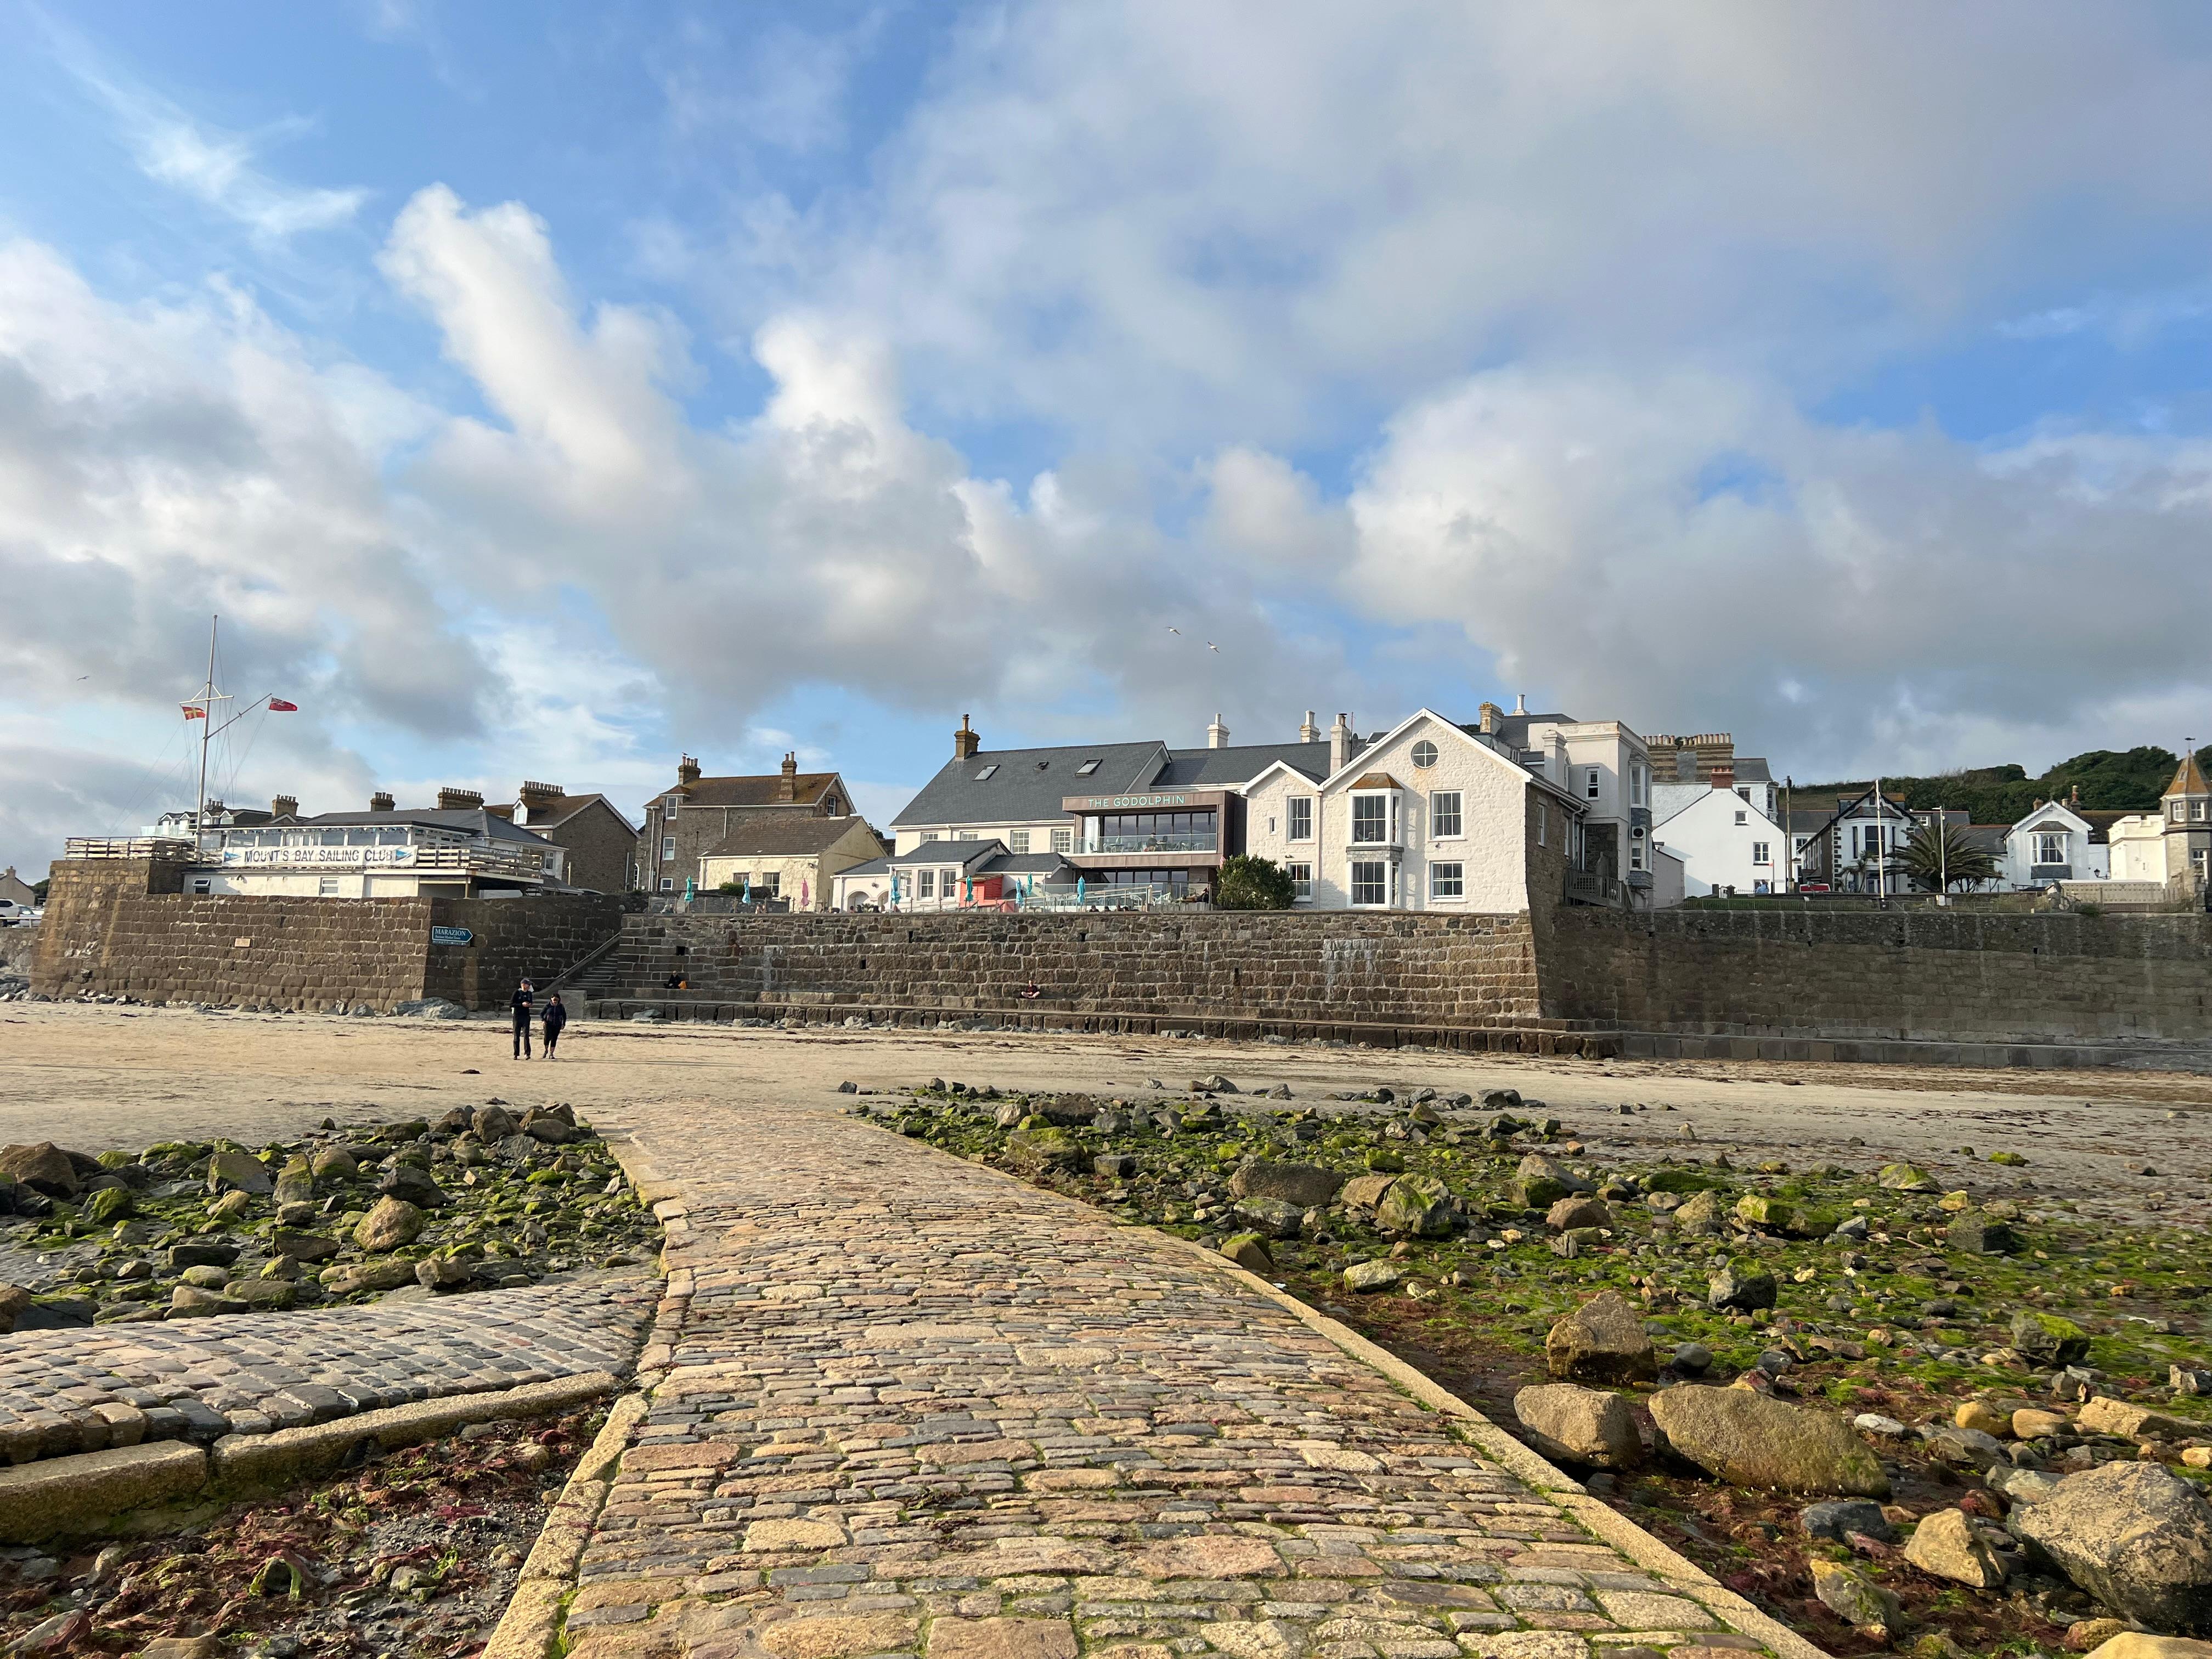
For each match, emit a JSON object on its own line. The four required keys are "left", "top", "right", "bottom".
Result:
{"left": 544, "top": 1108, "right": 1814, "bottom": 1659}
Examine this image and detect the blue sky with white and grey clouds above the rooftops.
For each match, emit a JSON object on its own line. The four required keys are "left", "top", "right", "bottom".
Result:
{"left": 0, "top": 0, "right": 2212, "bottom": 872}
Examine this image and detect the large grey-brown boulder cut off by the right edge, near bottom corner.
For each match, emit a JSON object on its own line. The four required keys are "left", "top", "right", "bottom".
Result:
{"left": 2011, "top": 1462, "right": 2212, "bottom": 1635}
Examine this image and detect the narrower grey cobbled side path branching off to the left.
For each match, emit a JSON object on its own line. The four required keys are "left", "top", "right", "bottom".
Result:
{"left": 0, "top": 1278, "right": 662, "bottom": 1462}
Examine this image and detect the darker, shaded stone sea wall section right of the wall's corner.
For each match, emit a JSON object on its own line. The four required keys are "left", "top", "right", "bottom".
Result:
{"left": 1539, "top": 905, "right": 2212, "bottom": 1042}
